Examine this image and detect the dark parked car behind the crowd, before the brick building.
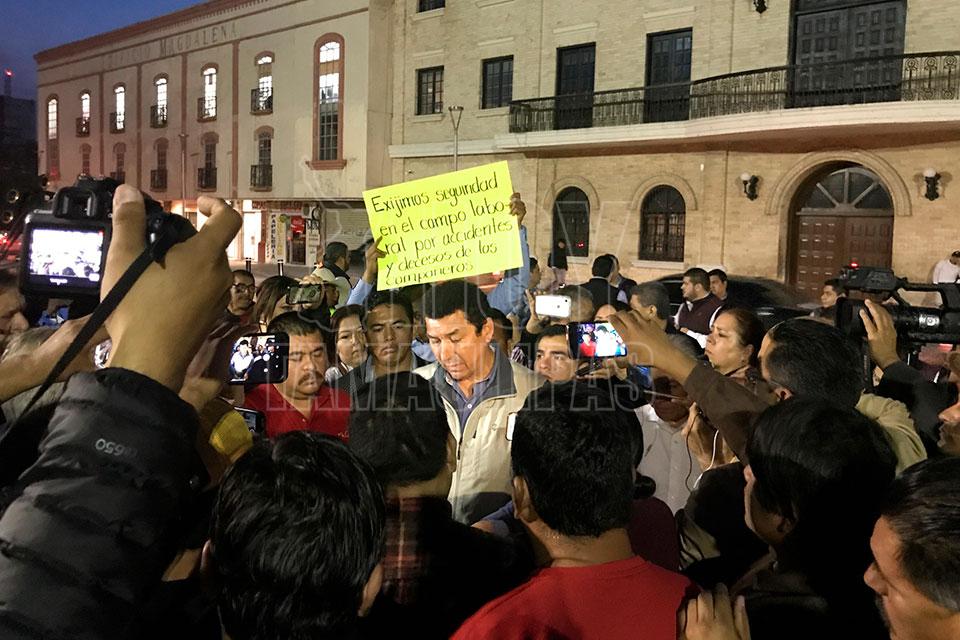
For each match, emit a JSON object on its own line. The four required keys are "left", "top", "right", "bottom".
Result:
{"left": 658, "top": 273, "right": 816, "bottom": 329}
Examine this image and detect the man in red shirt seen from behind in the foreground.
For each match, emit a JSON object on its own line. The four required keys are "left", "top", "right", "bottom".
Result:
{"left": 454, "top": 384, "right": 696, "bottom": 640}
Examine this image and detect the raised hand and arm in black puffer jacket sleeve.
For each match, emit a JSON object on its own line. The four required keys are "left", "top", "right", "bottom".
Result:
{"left": 0, "top": 185, "right": 241, "bottom": 640}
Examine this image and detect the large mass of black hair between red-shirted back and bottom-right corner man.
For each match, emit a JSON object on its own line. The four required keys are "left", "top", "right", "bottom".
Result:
{"left": 747, "top": 397, "right": 897, "bottom": 624}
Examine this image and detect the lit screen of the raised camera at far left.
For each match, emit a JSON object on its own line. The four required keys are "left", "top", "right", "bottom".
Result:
{"left": 27, "top": 227, "right": 104, "bottom": 288}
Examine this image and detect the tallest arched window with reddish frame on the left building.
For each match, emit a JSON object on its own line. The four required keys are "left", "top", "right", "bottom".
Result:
{"left": 313, "top": 34, "right": 344, "bottom": 169}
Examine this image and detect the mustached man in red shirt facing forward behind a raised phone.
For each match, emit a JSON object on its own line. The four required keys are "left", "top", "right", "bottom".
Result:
{"left": 244, "top": 312, "right": 350, "bottom": 440}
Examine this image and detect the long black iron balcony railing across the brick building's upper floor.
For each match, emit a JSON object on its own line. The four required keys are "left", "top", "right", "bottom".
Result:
{"left": 510, "top": 52, "right": 960, "bottom": 133}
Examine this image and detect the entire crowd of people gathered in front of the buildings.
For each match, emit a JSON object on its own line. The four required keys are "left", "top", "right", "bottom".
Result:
{"left": 0, "top": 186, "right": 960, "bottom": 640}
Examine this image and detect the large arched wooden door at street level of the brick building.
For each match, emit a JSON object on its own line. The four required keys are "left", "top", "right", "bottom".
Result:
{"left": 787, "top": 167, "right": 893, "bottom": 299}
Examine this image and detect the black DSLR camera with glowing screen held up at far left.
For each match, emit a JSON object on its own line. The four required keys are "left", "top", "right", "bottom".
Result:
{"left": 20, "top": 176, "right": 196, "bottom": 300}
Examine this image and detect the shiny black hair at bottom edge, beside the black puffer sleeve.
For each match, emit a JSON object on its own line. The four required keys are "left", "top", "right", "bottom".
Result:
{"left": 210, "top": 431, "right": 385, "bottom": 640}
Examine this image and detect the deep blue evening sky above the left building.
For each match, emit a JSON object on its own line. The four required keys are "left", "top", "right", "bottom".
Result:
{"left": 0, "top": 0, "right": 202, "bottom": 99}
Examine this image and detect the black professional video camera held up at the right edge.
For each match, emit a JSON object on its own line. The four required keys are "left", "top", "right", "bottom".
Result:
{"left": 837, "top": 267, "right": 960, "bottom": 348}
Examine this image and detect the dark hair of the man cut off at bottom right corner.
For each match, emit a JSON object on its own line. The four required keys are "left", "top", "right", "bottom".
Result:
{"left": 881, "top": 457, "right": 960, "bottom": 613}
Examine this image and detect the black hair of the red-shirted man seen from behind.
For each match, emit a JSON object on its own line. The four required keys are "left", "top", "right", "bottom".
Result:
{"left": 511, "top": 382, "right": 637, "bottom": 537}
